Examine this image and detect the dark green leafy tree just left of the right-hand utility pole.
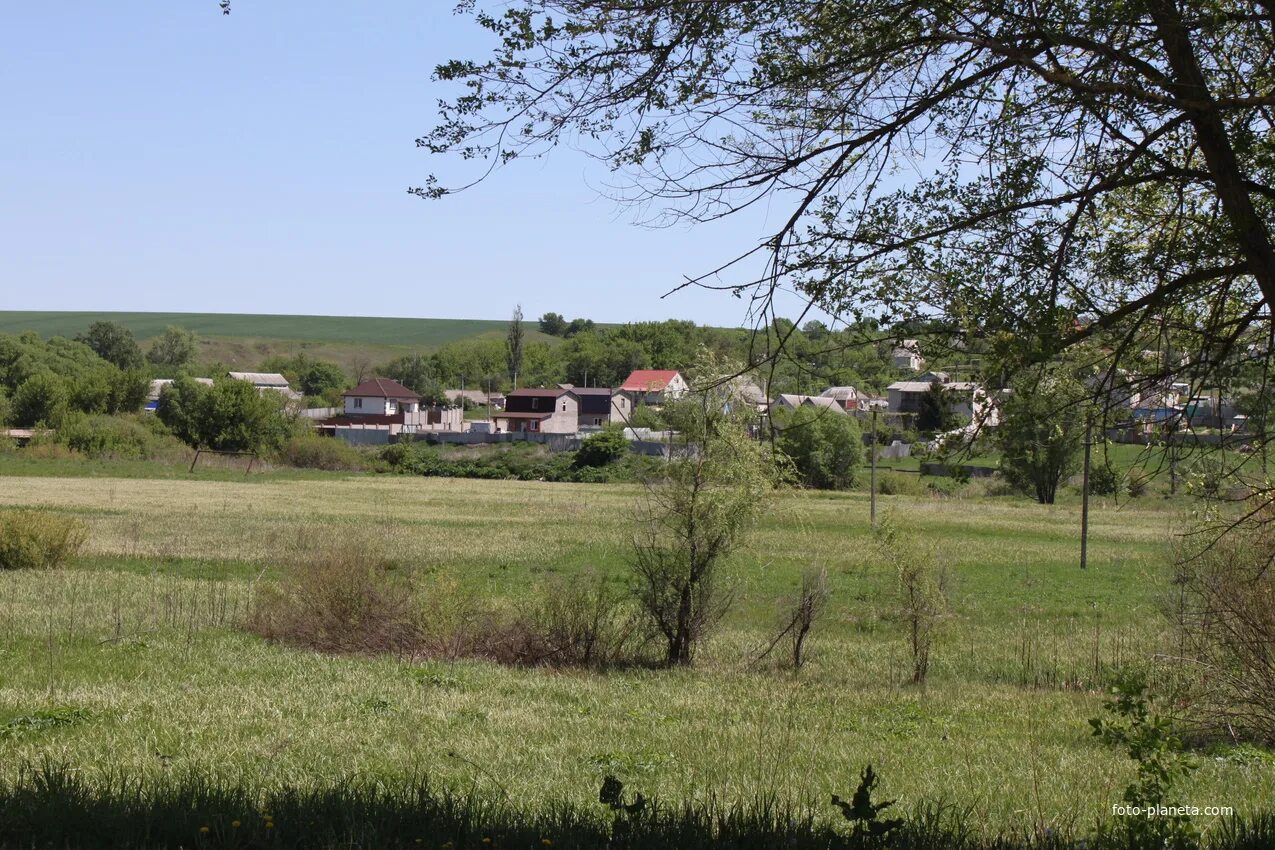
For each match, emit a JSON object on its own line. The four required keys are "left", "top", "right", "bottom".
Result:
{"left": 998, "top": 372, "right": 1086, "bottom": 505}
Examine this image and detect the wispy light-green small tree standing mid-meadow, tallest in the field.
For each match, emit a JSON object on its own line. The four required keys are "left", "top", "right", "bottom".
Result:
{"left": 632, "top": 371, "right": 776, "bottom": 666}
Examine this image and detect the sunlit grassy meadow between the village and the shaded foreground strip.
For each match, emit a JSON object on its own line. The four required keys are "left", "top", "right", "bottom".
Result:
{"left": 0, "top": 466, "right": 1275, "bottom": 831}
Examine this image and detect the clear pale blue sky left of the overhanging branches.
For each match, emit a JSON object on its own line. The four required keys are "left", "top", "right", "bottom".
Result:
{"left": 0, "top": 0, "right": 816, "bottom": 325}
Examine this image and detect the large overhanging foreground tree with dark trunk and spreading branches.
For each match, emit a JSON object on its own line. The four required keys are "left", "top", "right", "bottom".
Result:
{"left": 425, "top": 0, "right": 1275, "bottom": 423}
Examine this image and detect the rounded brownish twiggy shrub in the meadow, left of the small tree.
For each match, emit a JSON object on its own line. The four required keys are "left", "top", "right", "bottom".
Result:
{"left": 249, "top": 539, "right": 421, "bottom": 655}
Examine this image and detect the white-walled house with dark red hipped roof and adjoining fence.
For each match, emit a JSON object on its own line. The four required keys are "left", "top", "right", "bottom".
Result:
{"left": 315, "top": 377, "right": 465, "bottom": 442}
